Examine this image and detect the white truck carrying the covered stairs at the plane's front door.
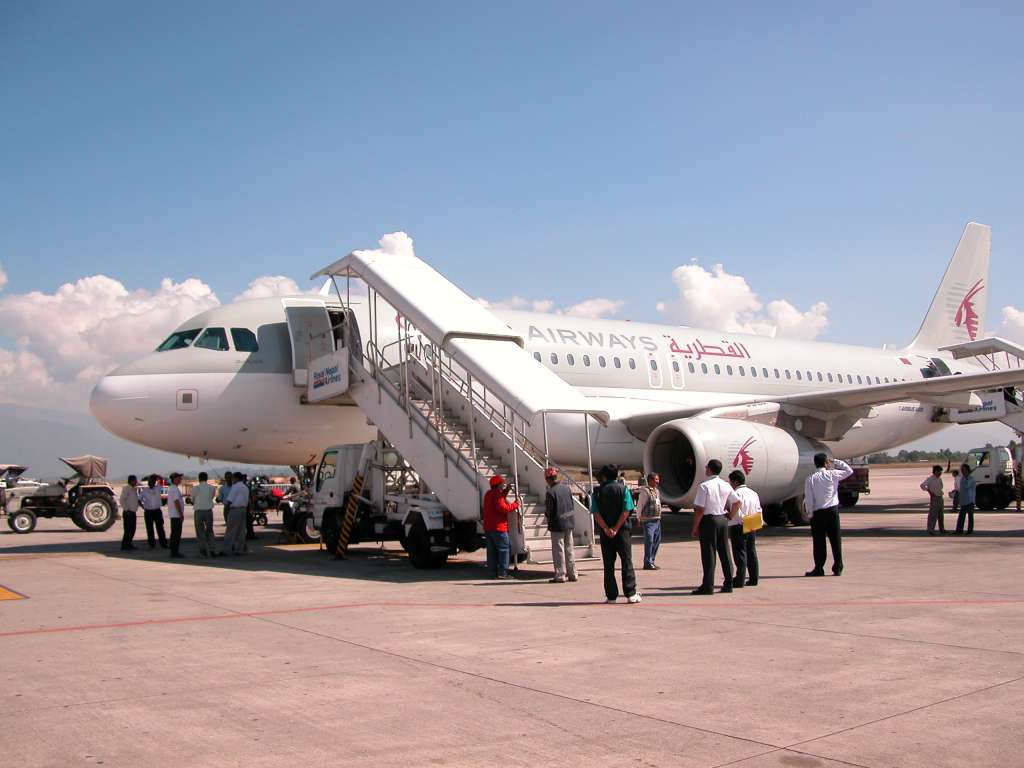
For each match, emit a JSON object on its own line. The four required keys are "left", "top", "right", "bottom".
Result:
{"left": 310, "top": 439, "right": 483, "bottom": 568}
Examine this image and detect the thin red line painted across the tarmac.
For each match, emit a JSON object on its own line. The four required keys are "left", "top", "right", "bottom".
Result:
{"left": 0, "top": 598, "right": 1024, "bottom": 638}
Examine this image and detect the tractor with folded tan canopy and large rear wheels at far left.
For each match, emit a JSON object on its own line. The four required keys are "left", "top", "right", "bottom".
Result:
{"left": 0, "top": 456, "right": 118, "bottom": 534}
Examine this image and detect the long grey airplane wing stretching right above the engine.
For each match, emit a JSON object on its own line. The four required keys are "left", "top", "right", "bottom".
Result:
{"left": 624, "top": 369, "right": 1024, "bottom": 440}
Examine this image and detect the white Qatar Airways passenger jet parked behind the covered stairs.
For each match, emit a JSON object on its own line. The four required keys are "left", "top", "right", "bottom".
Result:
{"left": 90, "top": 223, "right": 1024, "bottom": 506}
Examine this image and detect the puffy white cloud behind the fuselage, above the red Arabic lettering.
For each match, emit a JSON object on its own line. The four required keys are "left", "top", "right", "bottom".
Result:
{"left": 657, "top": 264, "right": 828, "bottom": 339}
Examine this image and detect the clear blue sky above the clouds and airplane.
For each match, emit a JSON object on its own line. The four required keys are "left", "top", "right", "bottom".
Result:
{"left": 0, "top": 2, "right": 1024, "bottom": 344}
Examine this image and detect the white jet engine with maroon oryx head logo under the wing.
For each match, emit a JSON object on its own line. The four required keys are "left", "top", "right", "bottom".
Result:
{"left": 643, "top": 417, "right": 829, "bottom": 507}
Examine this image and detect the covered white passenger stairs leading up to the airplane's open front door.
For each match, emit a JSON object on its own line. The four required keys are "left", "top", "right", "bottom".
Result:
{"left": 301, "top": 251, "right": 608, "bottom": 562}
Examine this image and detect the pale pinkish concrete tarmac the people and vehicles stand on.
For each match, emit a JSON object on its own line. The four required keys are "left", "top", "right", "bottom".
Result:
{"left": 0, "top": 468, "right": 1024, "bottom": 768}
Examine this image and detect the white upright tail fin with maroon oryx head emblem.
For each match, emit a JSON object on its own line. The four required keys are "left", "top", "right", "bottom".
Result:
{"left": 909, "top": 221, "right": 992, "bottom": 349}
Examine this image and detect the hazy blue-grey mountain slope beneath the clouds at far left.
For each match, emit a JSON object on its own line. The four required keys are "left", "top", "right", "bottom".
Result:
{"left": 0, "top": 404, "right": 290, "bottom": 480}
